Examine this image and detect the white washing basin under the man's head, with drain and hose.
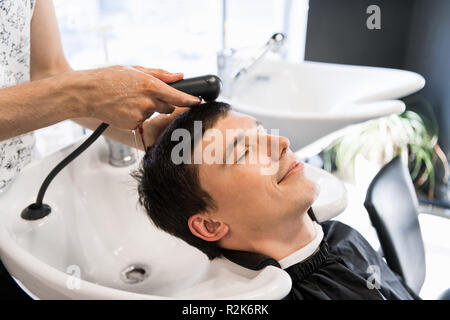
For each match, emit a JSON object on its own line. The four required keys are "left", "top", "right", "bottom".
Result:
{"left": 0, "top": 138, "right": 347, "bottom": 299}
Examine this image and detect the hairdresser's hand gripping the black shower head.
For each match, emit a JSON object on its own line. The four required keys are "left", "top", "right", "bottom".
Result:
{"left": 72, "top": 66, "right": 201, "bottom": 130}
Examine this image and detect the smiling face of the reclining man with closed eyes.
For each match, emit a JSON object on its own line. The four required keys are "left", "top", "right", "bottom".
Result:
{"left": 196, "top": 111, "right": 317, "bottom": 244}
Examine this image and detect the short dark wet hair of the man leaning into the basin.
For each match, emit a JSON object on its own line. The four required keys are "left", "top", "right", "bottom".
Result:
{"left": 133, "top": 102, "right": 231, "bottom": 259}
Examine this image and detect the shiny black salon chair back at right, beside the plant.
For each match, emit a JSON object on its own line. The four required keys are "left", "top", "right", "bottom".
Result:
{"left": 364, "top": 157, "right": 450, "bottom": 300}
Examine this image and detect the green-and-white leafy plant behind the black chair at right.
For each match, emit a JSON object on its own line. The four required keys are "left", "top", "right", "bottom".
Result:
{"left": 323, "top": 95, "right": 450, "bottom": 199}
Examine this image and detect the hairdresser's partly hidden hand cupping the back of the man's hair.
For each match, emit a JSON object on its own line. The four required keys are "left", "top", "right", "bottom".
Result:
{"left": 142, "top": 108, "right": 188, "bottom": 150}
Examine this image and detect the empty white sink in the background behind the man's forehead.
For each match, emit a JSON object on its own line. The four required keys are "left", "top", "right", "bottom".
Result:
{"left": 222, "top": 60, "right": 425, "bottom": 150}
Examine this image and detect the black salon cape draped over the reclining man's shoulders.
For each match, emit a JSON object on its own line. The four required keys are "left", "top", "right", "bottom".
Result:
{"left": 224, "top": 221, "right": 420, "bottom": 300}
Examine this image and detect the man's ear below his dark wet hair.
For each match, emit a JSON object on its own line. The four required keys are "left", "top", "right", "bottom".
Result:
{"left": 188, "top": 213, "right": 229, "bottom": 241}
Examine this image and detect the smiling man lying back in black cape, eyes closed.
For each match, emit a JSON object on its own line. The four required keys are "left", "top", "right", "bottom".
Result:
{"left": 136, "top": 102, "right": 419, "bottom": 299}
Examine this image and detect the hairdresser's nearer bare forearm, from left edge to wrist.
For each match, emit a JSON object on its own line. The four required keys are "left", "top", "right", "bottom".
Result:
{"left": 0, "top": 75, "right": 88, "bottom": 141}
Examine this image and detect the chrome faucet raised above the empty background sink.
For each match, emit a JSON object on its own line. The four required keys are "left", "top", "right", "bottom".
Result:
{"left": 217, "top": 32, "right": 286, "bottom": 98}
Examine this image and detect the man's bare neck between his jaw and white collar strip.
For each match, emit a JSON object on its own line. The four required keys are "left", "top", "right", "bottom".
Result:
{"left": 246, "top": 212, "right": 317, "bottom": 261}
